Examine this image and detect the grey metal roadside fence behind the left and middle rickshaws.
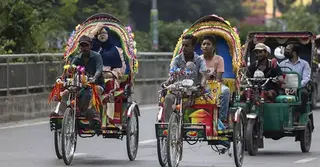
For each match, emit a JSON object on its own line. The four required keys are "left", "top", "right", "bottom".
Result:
{"left": 0, "top": 52, "right": 172, "bottom": 96}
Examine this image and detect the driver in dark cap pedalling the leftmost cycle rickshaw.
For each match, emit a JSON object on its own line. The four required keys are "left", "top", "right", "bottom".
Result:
{"left": 50, "top": 35, "right": 104, "bottom": 119}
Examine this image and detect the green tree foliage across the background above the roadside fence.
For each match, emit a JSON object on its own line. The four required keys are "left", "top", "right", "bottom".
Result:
{"left": 0, "top": 0, "right": 320, "bottom": 54}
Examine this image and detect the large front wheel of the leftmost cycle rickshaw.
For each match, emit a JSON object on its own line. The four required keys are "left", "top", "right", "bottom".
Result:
{"left": 61, "top": 107, "right": 77, "bottom": 165}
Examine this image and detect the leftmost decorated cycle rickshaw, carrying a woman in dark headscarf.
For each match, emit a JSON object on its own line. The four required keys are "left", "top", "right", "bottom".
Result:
{"left": 50, "top": 13, "right": 140, "bottom": 165}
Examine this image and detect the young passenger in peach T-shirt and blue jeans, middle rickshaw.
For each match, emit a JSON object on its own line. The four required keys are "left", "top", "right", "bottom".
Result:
{"left": 201, "top": 36, "right": 230, "bottom": 126}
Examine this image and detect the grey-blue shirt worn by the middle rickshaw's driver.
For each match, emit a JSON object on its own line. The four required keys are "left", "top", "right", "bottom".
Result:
{"left": 170, "top": 52, "right": 207, "bottom": 83}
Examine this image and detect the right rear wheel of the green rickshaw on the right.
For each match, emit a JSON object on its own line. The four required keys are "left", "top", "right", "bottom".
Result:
{"left": 300, "top": 119, "right": 312, "bottom": 153}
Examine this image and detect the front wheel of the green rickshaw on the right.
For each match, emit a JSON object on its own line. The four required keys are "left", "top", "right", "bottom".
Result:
{"left": 245, "top": 119, "right": 259, "bottom": 156}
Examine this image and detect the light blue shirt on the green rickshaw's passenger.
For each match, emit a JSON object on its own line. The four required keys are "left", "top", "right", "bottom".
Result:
{"left": 280, "top": 57, "right": 311, "bottom": 87}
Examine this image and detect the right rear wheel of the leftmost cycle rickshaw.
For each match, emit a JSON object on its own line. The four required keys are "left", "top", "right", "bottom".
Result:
{"left": 126, "top": 108, "right": 139, "bottom": 161}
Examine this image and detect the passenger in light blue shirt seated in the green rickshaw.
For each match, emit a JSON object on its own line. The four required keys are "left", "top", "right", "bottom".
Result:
{"left": 280, "top": 44, "right": 311, "bottom": 121}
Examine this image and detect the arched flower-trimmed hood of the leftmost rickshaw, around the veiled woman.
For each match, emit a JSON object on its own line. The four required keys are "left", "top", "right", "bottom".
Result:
{"left": 64, "top": 14, "right": 138, "bottom": 77}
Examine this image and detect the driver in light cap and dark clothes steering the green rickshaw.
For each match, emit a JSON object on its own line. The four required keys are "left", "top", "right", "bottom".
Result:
{"left": 241, "top": 43, "right": 282, "bottom": 101}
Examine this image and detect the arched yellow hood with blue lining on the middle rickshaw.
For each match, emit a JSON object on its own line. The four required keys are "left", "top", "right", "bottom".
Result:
{"left": 173, "top": 15, "right": 242, "bottom": 92}
